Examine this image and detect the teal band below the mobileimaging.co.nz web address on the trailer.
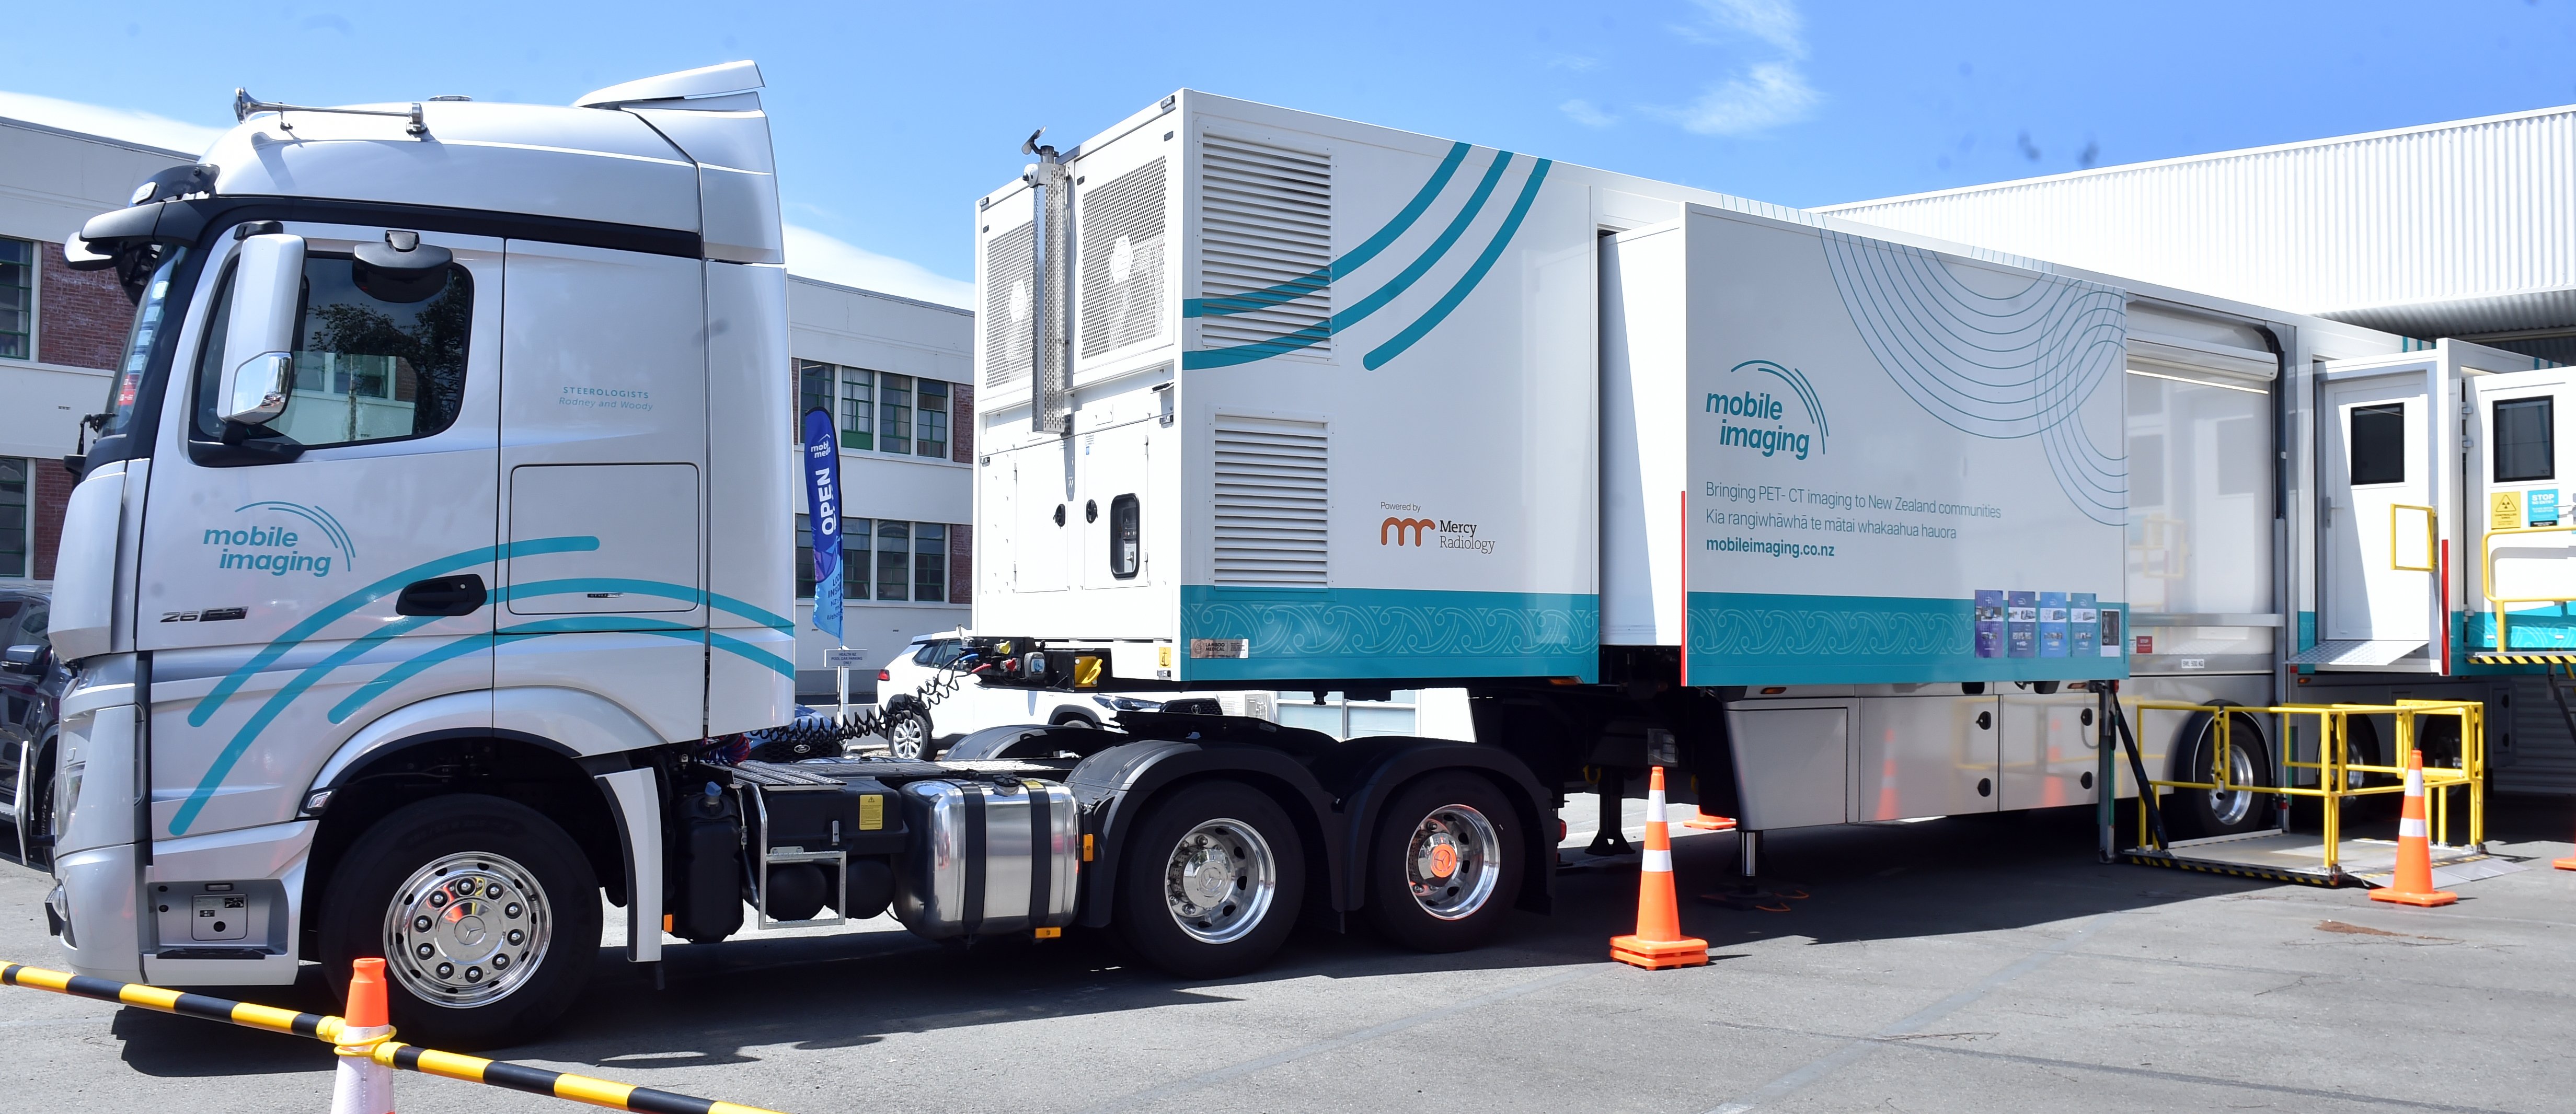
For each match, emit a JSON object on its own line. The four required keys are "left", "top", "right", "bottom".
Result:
{"left": 1685, "top": 591, "right": 2128, "bottom": 684}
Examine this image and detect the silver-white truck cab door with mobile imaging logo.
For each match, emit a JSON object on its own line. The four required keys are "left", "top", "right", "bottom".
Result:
{"left": 134, "top": 224, "right": 502, "bottom": 836}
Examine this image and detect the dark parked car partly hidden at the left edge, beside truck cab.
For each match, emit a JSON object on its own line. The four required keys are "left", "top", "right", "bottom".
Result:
{"left": 0, "top": 589, "right": 72, "bottom": 867}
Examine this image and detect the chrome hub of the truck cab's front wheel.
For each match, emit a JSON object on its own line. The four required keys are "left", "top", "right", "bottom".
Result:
{"left": 384, "top": 852, "right": 554, "bottom": 1006}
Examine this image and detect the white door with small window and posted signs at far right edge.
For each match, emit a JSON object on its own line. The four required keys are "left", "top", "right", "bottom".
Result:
{"left": 2460, "top": 368, "right": 2576, "bottom": 651}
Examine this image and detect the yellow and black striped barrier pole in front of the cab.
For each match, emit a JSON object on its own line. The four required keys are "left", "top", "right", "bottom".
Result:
{"left": 0, "top": 962, "right": 778, "bottom": 1114}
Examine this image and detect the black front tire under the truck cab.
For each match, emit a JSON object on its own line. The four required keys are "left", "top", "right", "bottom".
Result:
{"left": 319, "top": 795, "right": 600, "bottom": 1050}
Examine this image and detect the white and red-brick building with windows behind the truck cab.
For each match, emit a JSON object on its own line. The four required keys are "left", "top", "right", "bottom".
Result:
{"left": 0, "top": 118, "right": 974, "bottom": 694}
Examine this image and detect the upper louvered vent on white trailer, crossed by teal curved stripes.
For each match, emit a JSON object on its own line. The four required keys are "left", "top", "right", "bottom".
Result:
{"left": 1198, "top": 134, "right": 1332, "bottom": 353}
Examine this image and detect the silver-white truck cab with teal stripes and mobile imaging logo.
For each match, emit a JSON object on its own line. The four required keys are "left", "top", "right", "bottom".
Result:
{"left": 52, "top": 62, "right": 794, "bottom": 1039}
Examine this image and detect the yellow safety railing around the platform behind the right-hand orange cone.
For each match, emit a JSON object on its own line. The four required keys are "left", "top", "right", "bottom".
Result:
{"left": 2123, "top": 700, "right": 2486, "bottom": 872}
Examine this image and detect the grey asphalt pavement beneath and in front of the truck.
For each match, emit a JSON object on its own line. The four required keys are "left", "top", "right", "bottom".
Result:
{"left": 0, "top": 797, "right": 2576, "bottom": 1114}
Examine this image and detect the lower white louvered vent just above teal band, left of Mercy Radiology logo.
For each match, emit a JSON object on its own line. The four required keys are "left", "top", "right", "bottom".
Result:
{"left": 1216, "top": 414, "right": 1332, "bottom": 589}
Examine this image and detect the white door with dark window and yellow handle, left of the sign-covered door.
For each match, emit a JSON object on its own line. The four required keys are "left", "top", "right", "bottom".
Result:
{"left": 2303, "top": 355, "right": 2457, "bottom": 671}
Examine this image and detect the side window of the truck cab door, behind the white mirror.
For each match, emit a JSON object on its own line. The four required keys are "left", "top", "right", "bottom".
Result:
{"left": 196, "top": 252, "right": 474, "bottom": 448}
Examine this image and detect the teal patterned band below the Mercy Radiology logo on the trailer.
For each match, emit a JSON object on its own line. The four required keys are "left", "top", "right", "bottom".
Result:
{"left": 1177, "top": 584, "right": 1602, "bottom": 682}
